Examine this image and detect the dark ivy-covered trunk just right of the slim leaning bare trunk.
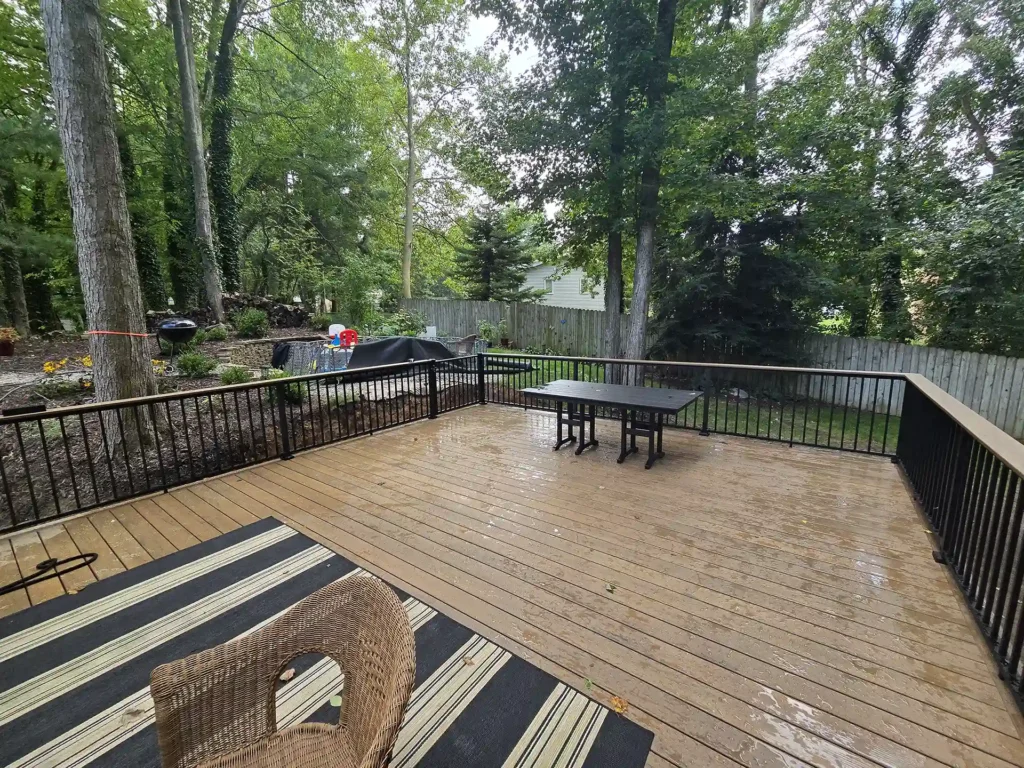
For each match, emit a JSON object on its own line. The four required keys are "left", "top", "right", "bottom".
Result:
{"left": 210, "top": 0, "right": 246, "bottom": 291}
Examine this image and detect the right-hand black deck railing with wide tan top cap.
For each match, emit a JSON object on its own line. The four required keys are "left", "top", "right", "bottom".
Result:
{"left": 896, "top": 374, "right": 1024, "bottom": 702}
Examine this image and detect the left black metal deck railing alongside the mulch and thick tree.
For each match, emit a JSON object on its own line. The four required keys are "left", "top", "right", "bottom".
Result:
{"left": 0, "top": 355, "right": 480, "bottom": 530}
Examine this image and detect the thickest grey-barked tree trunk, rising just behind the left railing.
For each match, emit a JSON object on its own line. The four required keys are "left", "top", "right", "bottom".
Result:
{"left": 41, "top": 0, "right": 157, "bottom": 411}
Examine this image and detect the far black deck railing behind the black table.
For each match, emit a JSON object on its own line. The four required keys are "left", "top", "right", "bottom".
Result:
{"left": 483, "top": 353, "right": 905, "bottom": 456}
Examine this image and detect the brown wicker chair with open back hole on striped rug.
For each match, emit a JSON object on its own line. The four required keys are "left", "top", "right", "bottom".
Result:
{"left": 150, "top": 577, "right": 416, "bottom": 768}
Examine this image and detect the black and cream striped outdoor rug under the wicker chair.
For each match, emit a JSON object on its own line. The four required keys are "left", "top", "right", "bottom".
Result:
{"left": 0, "top": 519, "right": 653, "bottom": 768}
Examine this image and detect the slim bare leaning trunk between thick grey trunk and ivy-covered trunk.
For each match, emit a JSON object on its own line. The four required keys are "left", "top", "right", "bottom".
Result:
{"left": 167, "top": 0, "right": 224, "bottom": 323}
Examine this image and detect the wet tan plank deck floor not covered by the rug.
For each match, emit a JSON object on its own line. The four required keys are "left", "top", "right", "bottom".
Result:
{"left": 0, "top": 407, "right": 1024, "bottom": 768}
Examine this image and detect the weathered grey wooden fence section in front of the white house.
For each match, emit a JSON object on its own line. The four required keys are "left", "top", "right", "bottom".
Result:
{"left": 401, "top": 299, "right": 629, "bottom": 356}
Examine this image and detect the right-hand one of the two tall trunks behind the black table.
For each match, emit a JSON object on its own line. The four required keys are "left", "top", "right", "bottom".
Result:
{"left": 625, "top": 0, "right": 678, "bottom": 370}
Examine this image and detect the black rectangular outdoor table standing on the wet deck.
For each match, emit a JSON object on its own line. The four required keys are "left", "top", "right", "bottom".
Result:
{"left": 521, "top": 379, "right": 701, "bottom": 469}
